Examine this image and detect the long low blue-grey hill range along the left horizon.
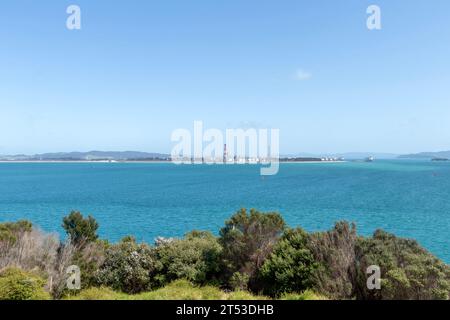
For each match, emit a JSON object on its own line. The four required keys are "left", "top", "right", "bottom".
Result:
{"left": 0, "top": 151, "right": 169, "bottom": 161}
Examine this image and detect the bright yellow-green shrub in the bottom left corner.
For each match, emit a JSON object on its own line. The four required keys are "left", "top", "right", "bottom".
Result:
{"left": 0, "top": 268, "right": 50, "bottom": 300}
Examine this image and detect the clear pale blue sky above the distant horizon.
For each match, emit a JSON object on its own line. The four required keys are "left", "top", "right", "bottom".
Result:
{"left": 0, "top": 0, "right": 450, "bottom": 154}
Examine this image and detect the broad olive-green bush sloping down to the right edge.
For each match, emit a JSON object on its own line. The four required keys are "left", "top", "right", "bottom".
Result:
{"left": 356, "top": 230, "right": 450, "bottom": 300}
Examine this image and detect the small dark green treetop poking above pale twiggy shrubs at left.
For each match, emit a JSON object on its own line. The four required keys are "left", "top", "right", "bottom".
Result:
{"left": 62, "top": 211, "right": 98, "bottom": 246}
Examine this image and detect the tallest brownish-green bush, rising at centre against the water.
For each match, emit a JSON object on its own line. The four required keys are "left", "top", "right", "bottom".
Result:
{"left": 220, "top": 209, "right": 285, "bottom": 291}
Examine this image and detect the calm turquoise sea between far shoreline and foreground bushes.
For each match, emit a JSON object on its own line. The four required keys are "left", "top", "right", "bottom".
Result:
{"left": 0, "top": 160, "right": 450, "bottom": 263}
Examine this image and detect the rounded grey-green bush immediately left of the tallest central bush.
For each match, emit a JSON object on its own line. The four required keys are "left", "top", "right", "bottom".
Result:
{"left": 155, "top": 231, "right": 222, "bottom": 285}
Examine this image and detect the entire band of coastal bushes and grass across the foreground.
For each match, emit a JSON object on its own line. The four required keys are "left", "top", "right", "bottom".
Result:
{"left": 0, "top": 209, "right": 450, "bottom": 300}
